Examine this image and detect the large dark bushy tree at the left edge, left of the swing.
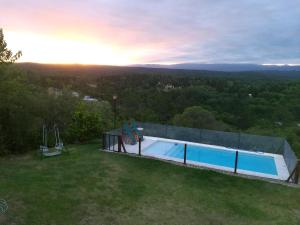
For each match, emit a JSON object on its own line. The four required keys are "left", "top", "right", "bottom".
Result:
{"left": 0, "top": 70, "right": 40, "bottom": 155}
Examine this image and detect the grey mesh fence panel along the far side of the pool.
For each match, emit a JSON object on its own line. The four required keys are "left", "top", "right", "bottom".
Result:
{"left": 109, "top": 122, "right": 294, "bottom": 158}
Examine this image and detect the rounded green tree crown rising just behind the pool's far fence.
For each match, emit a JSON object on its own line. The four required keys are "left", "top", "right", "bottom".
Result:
{"left": 173, "top": 106, "right": 227, "bottom": 130}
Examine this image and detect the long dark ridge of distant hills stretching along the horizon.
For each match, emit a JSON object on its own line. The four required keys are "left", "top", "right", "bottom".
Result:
{"left": 15, "top": 63, "right": 300, "bottom": 80}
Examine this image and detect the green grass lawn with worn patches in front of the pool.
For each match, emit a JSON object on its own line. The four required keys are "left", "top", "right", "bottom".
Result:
{"left": 0, "top": 143, "right": 300, "bottom": 225}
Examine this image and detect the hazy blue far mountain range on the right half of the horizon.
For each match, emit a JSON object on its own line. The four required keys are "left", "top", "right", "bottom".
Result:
{"left": 133, "top": 63, "right": 300, "bottom": 72}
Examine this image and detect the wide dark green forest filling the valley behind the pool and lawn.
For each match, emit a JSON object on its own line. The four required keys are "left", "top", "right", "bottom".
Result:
{"left": 0, "top": 63, "right": 300, "bottom": 154}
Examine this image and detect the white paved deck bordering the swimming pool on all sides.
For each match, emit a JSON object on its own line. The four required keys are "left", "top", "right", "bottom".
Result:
{"left": 119, "top": 136, "right": 289, "bottom": 180}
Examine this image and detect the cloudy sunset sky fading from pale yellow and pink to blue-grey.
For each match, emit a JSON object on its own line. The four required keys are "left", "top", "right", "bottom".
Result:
{"left": 0, "top": 0, "right": 300, "bottom": 65}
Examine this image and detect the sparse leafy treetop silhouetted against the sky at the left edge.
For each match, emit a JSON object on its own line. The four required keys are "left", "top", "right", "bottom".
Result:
{"left": 0, "top": 28, "right": 22, "bottom": 65}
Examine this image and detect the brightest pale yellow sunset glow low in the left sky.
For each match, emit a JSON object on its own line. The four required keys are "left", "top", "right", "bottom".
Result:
{"left": 4, "top": 31, "right": 140, "bottom": 65}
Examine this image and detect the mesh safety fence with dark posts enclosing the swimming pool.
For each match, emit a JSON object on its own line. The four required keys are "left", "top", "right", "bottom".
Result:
{"left": 103, "top": 122, "right": 300, "bottom": 183}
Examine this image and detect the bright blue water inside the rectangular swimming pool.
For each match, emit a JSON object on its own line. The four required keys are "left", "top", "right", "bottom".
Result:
{"left": 145, "top": 141, "right": 277, "bottom": 175}
